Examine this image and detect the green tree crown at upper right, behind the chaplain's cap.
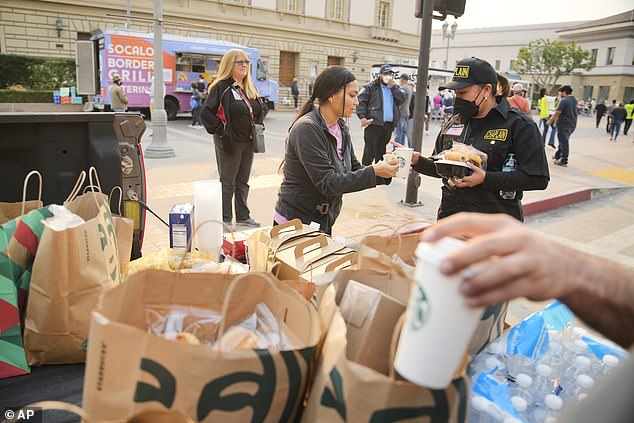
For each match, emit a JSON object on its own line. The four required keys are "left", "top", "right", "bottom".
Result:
{"left": 513, "top": 38, "right": 594, "bottom": 91}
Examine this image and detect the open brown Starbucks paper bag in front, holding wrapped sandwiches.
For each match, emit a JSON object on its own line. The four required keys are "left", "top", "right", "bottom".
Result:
{"left": 83, "top": 269, "right": 320, "bottom": 422}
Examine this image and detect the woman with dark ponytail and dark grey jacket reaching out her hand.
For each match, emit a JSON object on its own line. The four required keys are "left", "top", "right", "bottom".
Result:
{"left": 273, "top": 66, "right": 399, "bottom": 234}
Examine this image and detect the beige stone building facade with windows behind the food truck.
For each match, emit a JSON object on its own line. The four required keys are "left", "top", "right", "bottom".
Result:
{"left": 0, "top": 0, "right": 420, "bottom": 90}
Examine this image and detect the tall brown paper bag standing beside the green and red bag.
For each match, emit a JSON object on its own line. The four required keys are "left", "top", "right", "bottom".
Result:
{"left": 24, "top": 192, "right": 123, "bottom": 365}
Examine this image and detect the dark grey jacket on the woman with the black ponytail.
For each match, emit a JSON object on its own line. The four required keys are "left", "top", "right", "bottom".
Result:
{"left": 275, "top": 109, "right": 391, "bottom": 233}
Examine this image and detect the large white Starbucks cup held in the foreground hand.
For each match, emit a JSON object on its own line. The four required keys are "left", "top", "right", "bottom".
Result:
{"left": 394, "top": 238, "right": 483, "bottom": 389}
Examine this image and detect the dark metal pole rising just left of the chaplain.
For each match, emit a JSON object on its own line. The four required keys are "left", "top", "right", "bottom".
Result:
{"left": 403, "top": 1, "right": 434, "bottom": 207}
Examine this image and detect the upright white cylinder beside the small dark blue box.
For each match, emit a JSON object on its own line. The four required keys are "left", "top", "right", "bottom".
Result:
{"left": 194, "top": 180, "right": 223, "bottom": 254}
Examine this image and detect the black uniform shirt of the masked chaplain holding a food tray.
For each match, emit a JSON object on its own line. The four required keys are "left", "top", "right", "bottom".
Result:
{"left": 414, "top": 98, "right": 550, "bottom": 220}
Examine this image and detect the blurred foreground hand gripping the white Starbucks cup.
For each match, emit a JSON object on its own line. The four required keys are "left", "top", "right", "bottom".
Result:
{"left": 422, "top": 213, "right": 575, "bottom": 307}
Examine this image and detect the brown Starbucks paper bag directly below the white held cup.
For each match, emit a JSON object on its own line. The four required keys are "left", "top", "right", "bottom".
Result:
{"left": 302, "top": 298, "right": 469, "bottom": 423}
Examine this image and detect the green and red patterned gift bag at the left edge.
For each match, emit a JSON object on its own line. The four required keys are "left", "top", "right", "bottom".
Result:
{"left": 0, "top": 207, "right": 53, "bottom": 379}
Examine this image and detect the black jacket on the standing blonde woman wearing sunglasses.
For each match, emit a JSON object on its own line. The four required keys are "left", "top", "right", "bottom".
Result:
{"left": 200, "top": 78, "right": 266, "bottom": 154}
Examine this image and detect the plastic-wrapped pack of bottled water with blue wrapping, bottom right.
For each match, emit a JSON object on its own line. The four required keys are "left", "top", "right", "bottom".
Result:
{"left": 469, "top": 301, "right": 628, "bottom": 423}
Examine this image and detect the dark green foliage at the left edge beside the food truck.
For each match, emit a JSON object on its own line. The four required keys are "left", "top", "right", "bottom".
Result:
{"left": 0, "top": 54, "right": 75, "bottom": 90}
